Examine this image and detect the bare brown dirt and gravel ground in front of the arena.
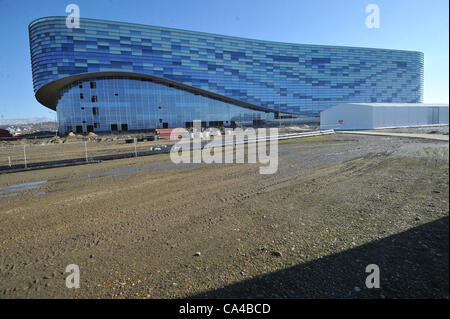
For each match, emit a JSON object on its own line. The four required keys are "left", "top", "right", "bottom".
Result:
{"left": 0, "top": 134, "right": 449, "bottom": 298}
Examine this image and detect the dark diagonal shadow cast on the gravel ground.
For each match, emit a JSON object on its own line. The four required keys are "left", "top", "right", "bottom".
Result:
{"left": 189, "top": 217, "right": 449, "bottom": 299}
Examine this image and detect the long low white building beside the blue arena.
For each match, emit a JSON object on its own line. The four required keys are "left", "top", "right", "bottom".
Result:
{"left": 320, "top": 103, "right": 448, "bottom": 130}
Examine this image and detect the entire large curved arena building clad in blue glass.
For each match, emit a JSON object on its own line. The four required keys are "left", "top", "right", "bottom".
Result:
{"left": 29, "top": 17, "right": 423, "bottom": 134}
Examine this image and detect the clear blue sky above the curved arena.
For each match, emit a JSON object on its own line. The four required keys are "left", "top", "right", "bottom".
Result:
{"left": 0, "top": 0, "right": 449, "bottom": 119}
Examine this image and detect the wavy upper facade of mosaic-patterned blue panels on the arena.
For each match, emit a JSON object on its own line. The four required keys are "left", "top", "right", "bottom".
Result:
{"left": 29, "top": 17, "right": 423, "bottom": 134}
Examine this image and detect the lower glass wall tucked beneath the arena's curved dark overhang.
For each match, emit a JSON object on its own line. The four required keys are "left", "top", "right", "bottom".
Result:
{"left": 57, "top": 77, "right": 273, "bottom": 133}
